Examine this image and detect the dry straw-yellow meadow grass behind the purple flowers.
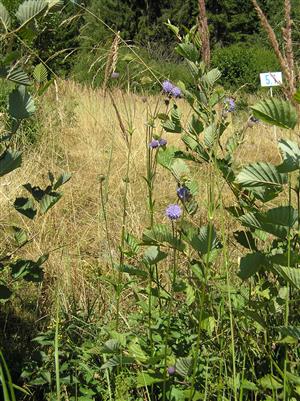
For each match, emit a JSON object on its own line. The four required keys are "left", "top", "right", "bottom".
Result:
{"left": 0, "top": 82, "right": 290, "bottom": 310}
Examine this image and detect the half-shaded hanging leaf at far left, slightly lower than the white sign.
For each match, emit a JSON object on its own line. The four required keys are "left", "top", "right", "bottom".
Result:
{"left": 8, "top": 85, "right": 35, "bottom": 120}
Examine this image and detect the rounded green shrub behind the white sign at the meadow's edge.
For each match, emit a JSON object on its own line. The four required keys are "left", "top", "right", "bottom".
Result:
{"left": 212, "top": 43, "right": 279, "bottom": 92}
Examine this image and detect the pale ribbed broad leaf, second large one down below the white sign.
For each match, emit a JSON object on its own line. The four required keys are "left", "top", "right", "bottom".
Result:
{"left": 236, "top": 163, "right": 287, "bottom": 188}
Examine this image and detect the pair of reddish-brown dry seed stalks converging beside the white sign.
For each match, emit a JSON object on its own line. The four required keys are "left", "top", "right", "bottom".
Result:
{"left": 251, "top": 0, "right": 296, "bottom": 99}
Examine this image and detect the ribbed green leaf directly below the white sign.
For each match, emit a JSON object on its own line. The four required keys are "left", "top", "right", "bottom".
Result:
{"left": 251, "top": 98, "right": 298, "bottom": 129}
